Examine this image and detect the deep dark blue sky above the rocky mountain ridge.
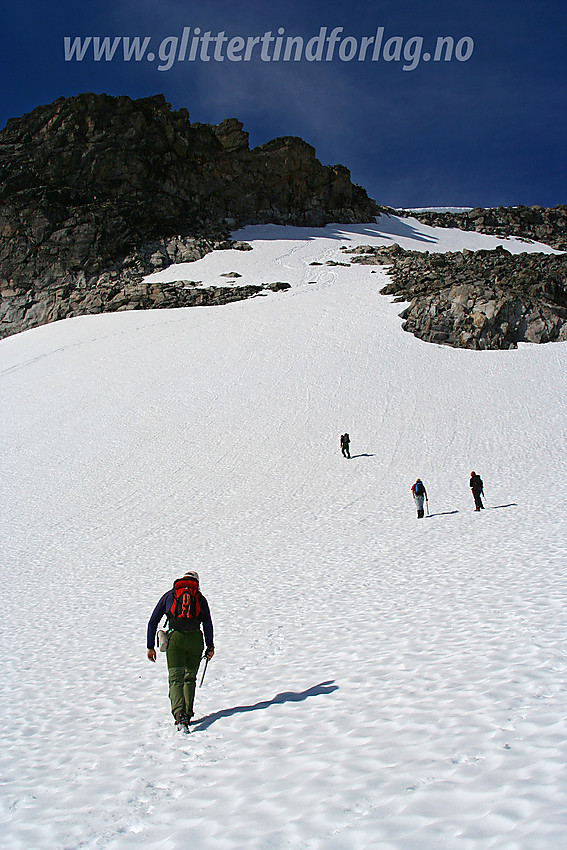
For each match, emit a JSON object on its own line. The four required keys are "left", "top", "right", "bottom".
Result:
{"left": 0, "top": 0, "right": 567, "bottom": 206}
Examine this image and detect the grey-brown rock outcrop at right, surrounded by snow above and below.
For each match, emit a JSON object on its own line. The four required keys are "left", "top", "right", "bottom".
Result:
{"left": 349, "top": 245, "right": 567, "bottom": 349}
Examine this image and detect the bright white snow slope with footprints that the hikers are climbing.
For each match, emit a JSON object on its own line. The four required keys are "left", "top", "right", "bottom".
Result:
{"left": 0, "top": 218, "right": 567, "bottom": 850}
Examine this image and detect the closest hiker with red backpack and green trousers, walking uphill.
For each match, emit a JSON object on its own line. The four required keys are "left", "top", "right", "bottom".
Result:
{"left": 148, "top": 570, "right": 215, "bottom": 731}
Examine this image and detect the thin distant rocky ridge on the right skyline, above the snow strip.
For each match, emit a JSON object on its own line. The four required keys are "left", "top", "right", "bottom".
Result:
{"left": 400, "top": 204, "right": 567, "bottom": 251}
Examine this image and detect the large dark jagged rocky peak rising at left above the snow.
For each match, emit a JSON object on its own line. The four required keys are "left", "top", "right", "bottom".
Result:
{"left": 0, "top": 89, "right": 378, "bottom": 337}
